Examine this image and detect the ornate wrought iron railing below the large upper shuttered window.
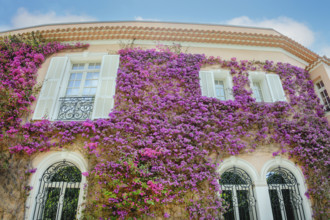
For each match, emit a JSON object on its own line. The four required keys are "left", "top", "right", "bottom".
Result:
{"left": 57, "top": 97, "right": 94, "bottom": 121}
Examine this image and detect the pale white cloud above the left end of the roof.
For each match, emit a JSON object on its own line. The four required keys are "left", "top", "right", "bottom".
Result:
{"left": 10, "top": 8, "right": 97, "bottom": 28}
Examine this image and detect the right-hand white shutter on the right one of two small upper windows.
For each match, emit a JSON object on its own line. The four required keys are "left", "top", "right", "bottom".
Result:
{"left": 266, "top": 74, "right": 286, "bottom": 102}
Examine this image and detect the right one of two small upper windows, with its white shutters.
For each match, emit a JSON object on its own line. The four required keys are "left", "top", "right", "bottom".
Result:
{"left": 249, "top": 72, "right": 286, "bottom": 102}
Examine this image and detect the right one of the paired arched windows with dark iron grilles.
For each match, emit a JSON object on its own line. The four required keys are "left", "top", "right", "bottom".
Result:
{"left": 266, "top": 167, "right": 305, "bottom": 220}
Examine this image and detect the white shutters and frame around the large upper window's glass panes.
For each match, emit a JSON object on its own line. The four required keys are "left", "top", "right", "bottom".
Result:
{"left": 32, "top": 52, "right": 119, "bottom": 121}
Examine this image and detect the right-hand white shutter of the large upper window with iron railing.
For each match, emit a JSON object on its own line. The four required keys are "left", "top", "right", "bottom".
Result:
{"left": 92, "top": 55, "right": 119, "bottom": 119}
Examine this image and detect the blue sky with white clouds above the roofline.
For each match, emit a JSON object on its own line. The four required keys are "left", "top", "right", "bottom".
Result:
{"left": 0, "top": 0, "right": 330, "bottom": 57}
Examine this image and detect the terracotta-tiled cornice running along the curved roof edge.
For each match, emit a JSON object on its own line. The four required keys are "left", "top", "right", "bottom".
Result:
{"left": 0, "top": 22, "right": 320, "bottom": 65}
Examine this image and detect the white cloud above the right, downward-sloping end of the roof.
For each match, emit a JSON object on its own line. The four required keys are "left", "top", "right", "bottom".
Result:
{"left": 226, "top": 16, "right": 315, "bottom": 47}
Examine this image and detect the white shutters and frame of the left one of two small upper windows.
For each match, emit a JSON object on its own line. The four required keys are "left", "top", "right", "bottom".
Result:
{"left": 199, "top": 69, "right": 234, "bottom": 101}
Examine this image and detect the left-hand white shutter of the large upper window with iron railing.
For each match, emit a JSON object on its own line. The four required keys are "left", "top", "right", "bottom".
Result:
{"left": 32, "top": 57, "right": 68, "bottom": 120}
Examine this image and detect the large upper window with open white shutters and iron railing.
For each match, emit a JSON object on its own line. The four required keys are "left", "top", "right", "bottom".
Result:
{"left": 33, "top": 53, "right": 119, "bottom": 120}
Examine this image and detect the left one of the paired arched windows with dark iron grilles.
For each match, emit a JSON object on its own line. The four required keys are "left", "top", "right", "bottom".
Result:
{"left": 220, "top": 167, "right": 257, "bottom": 220}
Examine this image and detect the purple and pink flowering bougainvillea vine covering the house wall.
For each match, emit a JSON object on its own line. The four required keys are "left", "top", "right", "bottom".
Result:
{"left": 0, "top": 34, "right": 330, "bottom": 219}
